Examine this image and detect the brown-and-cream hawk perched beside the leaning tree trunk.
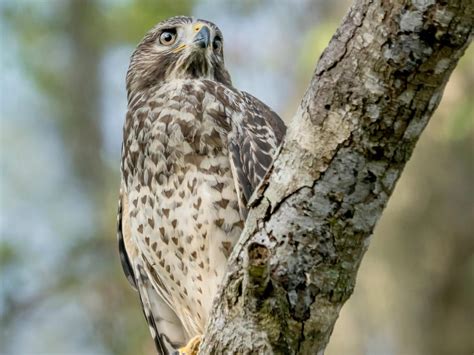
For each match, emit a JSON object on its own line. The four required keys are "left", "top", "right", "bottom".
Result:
{"left": 118, "top": 16, "right": 286, "bottom": 354}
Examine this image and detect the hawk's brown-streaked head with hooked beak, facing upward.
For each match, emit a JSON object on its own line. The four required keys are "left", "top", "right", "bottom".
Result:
{"left": 127, "top": 16, "right": 231, "bottom": 95}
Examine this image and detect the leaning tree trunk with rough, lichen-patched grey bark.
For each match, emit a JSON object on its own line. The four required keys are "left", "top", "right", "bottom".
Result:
{"left": 200, "top": 0, "right": 474, "bottom": 354}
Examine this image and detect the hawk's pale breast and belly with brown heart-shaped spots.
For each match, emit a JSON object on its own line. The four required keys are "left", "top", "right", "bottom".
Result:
{"left": 128, "top": 80, "right": 243, "bottom": 335}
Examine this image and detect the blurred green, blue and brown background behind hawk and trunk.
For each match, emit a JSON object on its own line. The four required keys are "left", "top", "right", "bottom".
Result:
{"left": 0, "top": 0, "right": 474, "bottom": 355}
